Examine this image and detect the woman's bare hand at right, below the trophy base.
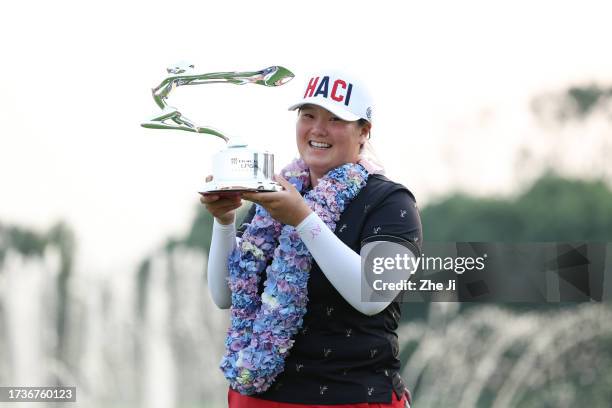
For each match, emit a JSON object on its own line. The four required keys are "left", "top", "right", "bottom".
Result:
{"left": 241, "top": 174, "right": 312, "bottom": 227}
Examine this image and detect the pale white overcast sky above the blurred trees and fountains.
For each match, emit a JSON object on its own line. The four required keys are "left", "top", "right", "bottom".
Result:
{"left": 0, "top": 0, "right": 612, "bottom": 274}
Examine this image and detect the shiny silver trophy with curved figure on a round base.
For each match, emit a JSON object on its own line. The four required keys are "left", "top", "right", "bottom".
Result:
{"left": 142, "top": 64, "right": 294, "bottom": 194}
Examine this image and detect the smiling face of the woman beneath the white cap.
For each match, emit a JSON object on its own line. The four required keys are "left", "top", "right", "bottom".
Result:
{"left": 296, "top": 105, "right": 370, "bottom": 185}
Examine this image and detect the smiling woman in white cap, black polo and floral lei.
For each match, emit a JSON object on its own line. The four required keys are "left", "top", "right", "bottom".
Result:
{"left": 201, "top": 72, "right": 422, "bottom": 408}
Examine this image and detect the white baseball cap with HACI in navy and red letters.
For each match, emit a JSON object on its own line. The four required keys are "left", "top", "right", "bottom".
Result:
{"left": 289, "top": 71, "right": 372, "bottom": 123}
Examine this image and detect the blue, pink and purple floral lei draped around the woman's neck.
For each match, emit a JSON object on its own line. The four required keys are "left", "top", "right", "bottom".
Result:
{"left": 220, "top": 159, "right": 368, "bottom": 395}
